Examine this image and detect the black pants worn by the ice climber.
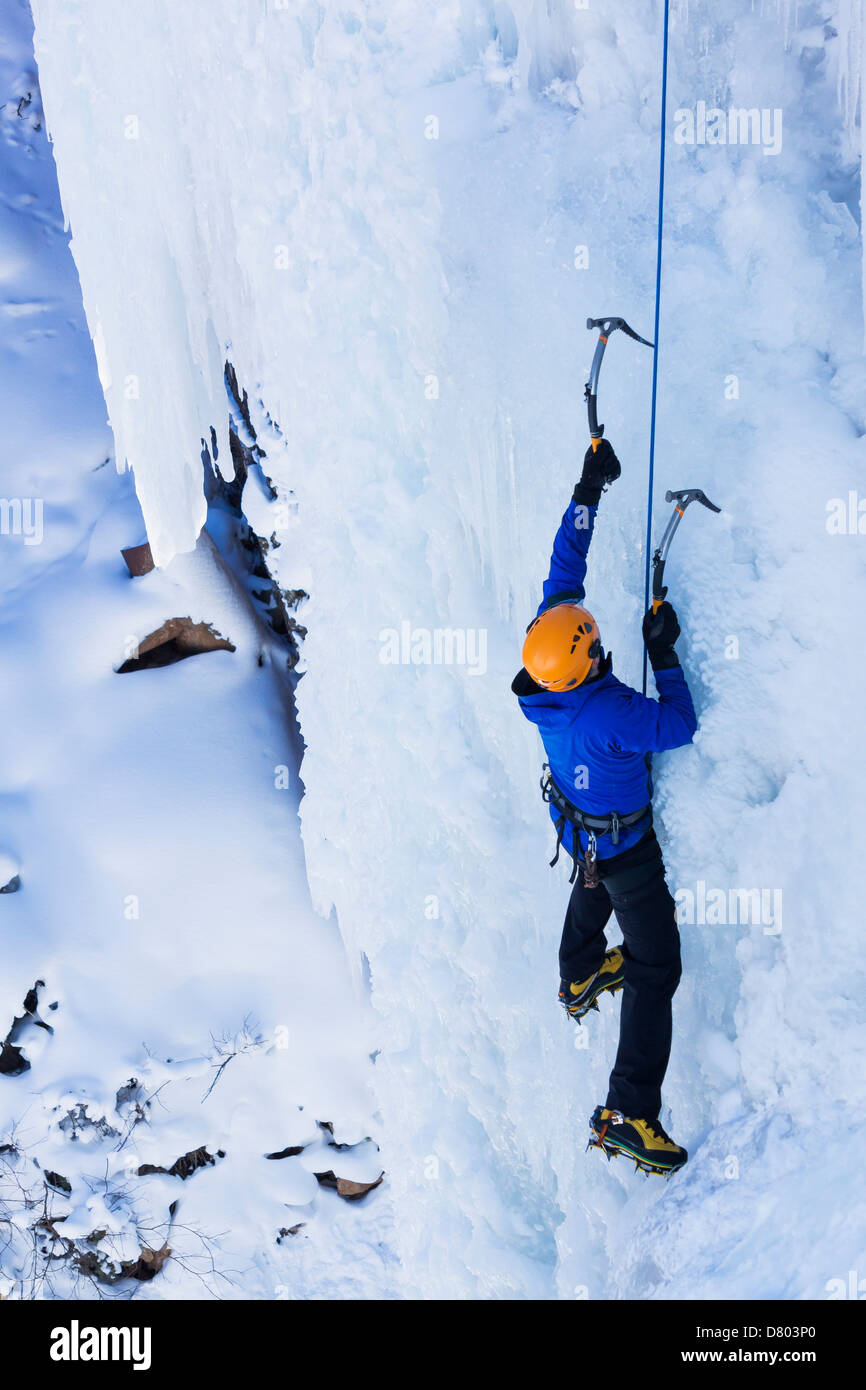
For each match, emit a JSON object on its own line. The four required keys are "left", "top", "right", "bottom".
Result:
{"left": 559, "top": 830, "right": 681, "bottom": 1120}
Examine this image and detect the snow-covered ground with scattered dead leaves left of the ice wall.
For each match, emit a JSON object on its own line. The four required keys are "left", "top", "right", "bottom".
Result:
{"left": 0, "top": 6, "right": 391, "bottom": 1298}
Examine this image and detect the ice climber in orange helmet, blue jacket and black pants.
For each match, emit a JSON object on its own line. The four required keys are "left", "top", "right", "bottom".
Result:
{"left": 512, "top": 439, "right": 696, "bottom": 1176}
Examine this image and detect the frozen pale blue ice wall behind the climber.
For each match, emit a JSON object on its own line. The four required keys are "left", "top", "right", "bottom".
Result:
{"left": 33, "top": 0, "right": 866, "bottom": 1298}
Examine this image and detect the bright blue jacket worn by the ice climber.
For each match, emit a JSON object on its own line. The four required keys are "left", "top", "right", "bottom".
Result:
{"left": 512, "top": 489, "right": 698, "bottom": 859}
